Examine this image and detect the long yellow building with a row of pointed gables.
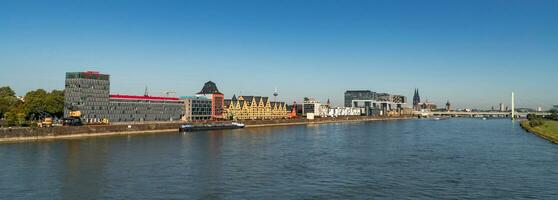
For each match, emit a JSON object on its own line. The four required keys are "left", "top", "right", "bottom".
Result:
{"left": 223, "top": 95, "right": 289, "bottom": 120}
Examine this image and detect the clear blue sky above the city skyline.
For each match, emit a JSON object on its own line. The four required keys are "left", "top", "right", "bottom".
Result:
{"left": 0, "top": 0, "right": 558, "bottom": 108}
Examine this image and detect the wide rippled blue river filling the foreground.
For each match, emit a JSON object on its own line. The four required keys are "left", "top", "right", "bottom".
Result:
{"left": 0, "top": 119, "right": 558, "bottom": 199}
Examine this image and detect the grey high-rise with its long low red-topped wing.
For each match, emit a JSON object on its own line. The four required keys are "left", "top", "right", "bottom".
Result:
{"left": 64, "top": 71, "right": 184, "bottom": 123}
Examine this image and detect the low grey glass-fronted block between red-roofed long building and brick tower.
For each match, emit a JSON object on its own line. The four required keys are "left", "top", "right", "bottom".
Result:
{"left": 180, "top": 96, "right": 212, "bottom": 122}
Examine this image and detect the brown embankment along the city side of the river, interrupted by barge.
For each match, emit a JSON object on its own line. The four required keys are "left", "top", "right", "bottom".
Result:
{"left": 0, "top": 116, "right": 412, "bottom": 143}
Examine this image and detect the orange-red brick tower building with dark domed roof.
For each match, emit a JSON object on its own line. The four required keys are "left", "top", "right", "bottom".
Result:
{"left": 197, "top": 81, "right": 225, "bottom": 119}
